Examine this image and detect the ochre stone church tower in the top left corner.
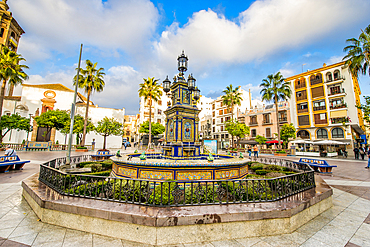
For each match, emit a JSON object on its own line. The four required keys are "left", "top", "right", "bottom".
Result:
{"left": 0, "top": 0, "right": 24, "bottom": 96}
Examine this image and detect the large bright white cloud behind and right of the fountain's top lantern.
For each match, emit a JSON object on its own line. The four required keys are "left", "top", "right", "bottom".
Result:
{"left": 154, "top": 0, "right": 369, "bottom": 70}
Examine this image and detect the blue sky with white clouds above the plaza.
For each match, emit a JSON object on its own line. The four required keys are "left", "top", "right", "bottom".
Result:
{"left": 8, "top": 0, "right": 370, "bottom": 115}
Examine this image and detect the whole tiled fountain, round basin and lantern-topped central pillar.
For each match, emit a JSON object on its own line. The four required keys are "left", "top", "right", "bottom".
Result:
{"left": 112, "top": 52, "right": 248, "bottom": 180}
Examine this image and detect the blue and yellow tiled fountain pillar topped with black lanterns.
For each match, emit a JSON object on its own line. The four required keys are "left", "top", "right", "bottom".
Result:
{"left": 163, "top": 52, "right": 200, "bottom": 159}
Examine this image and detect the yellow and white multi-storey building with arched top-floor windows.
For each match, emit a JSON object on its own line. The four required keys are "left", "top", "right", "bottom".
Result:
{"left": 286, "top": 62, "right": 365, "bottom": 155}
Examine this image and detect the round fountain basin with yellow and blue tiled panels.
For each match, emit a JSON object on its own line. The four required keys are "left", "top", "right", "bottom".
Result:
{"left": 111, "top": 153, "right": 250, "bottom": 181}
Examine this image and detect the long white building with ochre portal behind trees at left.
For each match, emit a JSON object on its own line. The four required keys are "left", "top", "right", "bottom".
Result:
{"left": 3, "top": 84, "right": 125, "bottom": 148}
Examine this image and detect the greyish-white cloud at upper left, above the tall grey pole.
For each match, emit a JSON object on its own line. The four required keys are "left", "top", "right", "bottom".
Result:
{"left": 9, "top": 0, "right": 159, "bottom": 60}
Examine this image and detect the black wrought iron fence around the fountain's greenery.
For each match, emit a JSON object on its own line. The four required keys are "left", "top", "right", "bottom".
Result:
{"left": 39, "top": 155, "right": 315, "bottom": 207}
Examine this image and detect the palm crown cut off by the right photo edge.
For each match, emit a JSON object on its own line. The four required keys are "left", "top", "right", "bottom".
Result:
{"left": 343, "top": 25, "right": 370, "bottom": 78}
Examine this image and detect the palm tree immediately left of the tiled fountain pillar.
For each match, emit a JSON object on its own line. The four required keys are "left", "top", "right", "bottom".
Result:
{"left": 139, "top": 77, "right": 162, "bottom": 147}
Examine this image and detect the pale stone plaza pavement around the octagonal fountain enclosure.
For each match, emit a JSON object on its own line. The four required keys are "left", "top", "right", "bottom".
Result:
{"left": 0, "top": 150, "right": 370, "bottom": 247}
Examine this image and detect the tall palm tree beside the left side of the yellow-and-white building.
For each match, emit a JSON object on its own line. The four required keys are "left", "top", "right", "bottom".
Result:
{"left": 260, "top": 72, "right": 292, "bottom": 149}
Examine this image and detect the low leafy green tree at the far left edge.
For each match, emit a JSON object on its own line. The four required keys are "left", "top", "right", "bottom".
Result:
{"left": 0, "top": 114, "right": 31, "bottom": 139}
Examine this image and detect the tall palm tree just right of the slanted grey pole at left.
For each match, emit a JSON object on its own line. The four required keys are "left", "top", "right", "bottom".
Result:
{"left": 74, "top": 60, "right": 105, "bottom": 146}
